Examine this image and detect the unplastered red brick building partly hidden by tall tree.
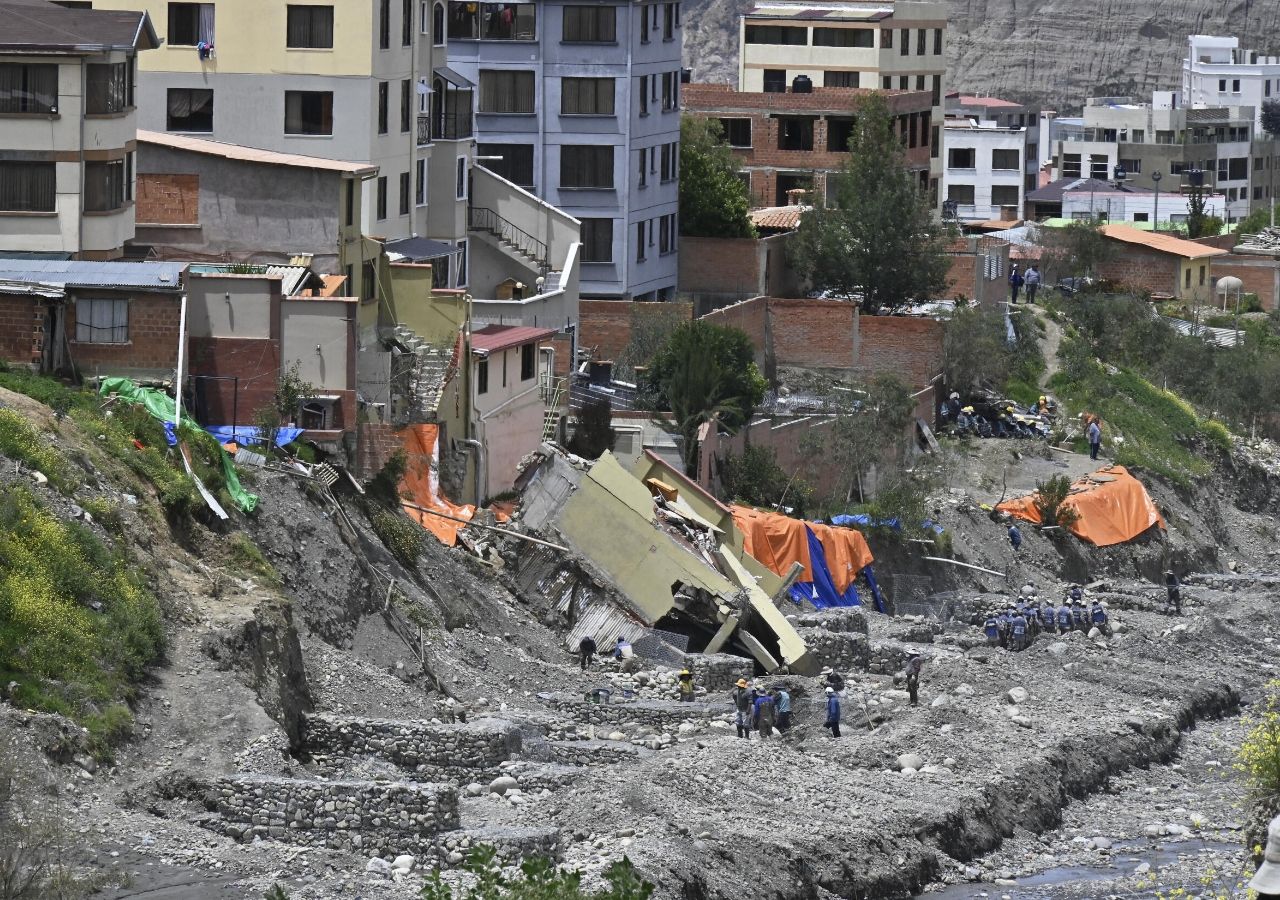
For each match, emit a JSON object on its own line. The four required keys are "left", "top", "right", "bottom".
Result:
{"left": 682, "top": 84, "right": 933, "bottom": 206}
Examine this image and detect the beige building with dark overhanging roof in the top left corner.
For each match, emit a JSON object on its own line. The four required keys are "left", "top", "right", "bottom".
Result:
{"left": 0, "top": 0, "right": 159, "bottom": 260}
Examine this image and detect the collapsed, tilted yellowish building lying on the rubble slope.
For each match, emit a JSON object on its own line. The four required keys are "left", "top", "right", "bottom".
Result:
{"left": 515, "top": 444, "right": 818, "bottom": 675}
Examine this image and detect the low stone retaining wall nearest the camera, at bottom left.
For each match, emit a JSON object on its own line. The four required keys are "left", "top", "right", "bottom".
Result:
{"left": 205, "top": 775, "right": 458, "bottom": 854}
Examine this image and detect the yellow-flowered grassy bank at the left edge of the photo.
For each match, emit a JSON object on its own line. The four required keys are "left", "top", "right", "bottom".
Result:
{"left": 0, "top": 488, "right": 164, "bottom": 759}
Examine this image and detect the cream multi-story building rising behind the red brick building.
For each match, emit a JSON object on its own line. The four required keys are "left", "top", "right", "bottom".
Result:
{"left": 737, "top": 0, "right": 947, "bottom": 204}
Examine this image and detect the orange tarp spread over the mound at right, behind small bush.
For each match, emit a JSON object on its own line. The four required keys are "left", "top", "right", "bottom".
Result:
{"left": 996, "top": 466, "right": 1165, "bottom": 547}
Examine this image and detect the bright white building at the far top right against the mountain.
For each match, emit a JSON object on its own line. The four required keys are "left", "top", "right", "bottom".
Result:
{"left": 1183, "top": 35, "right": 1280, "bottom": 136}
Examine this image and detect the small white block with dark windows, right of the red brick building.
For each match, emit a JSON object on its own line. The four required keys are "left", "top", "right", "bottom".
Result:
{"left": 942, "top": 118, "right": 1027, "bottom": 221}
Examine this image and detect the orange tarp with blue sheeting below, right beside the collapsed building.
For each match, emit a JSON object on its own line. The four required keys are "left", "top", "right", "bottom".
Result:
{"left": 730, "top": 506, "right": 874, "bottom": 594}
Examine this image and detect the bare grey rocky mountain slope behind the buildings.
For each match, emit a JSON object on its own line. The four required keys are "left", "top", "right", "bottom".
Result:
{"left": 685, "top": 0, "right": 1280, "bottom": 113}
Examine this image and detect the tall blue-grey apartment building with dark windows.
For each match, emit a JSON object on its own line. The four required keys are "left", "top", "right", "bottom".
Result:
{"left": 448, "top": 0, "right": 682, "bottom": 300}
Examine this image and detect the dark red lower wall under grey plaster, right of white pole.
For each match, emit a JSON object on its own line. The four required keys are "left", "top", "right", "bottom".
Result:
{"left": 187, "top": 337, "right": 280, "bottom": 425}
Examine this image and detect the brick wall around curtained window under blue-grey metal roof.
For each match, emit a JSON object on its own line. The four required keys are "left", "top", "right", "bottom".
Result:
{"left": 67, "top": 291, "right": 180, "bottom": 375}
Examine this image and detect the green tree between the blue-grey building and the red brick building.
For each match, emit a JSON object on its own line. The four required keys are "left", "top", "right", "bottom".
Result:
{"left": 680, "top": 115, "right": 755, "bottom": 238}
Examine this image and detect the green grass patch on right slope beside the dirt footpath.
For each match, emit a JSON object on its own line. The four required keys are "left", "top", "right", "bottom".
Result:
{"left": 1050, "top": 356, "right": 1231, "bottom": 486}
